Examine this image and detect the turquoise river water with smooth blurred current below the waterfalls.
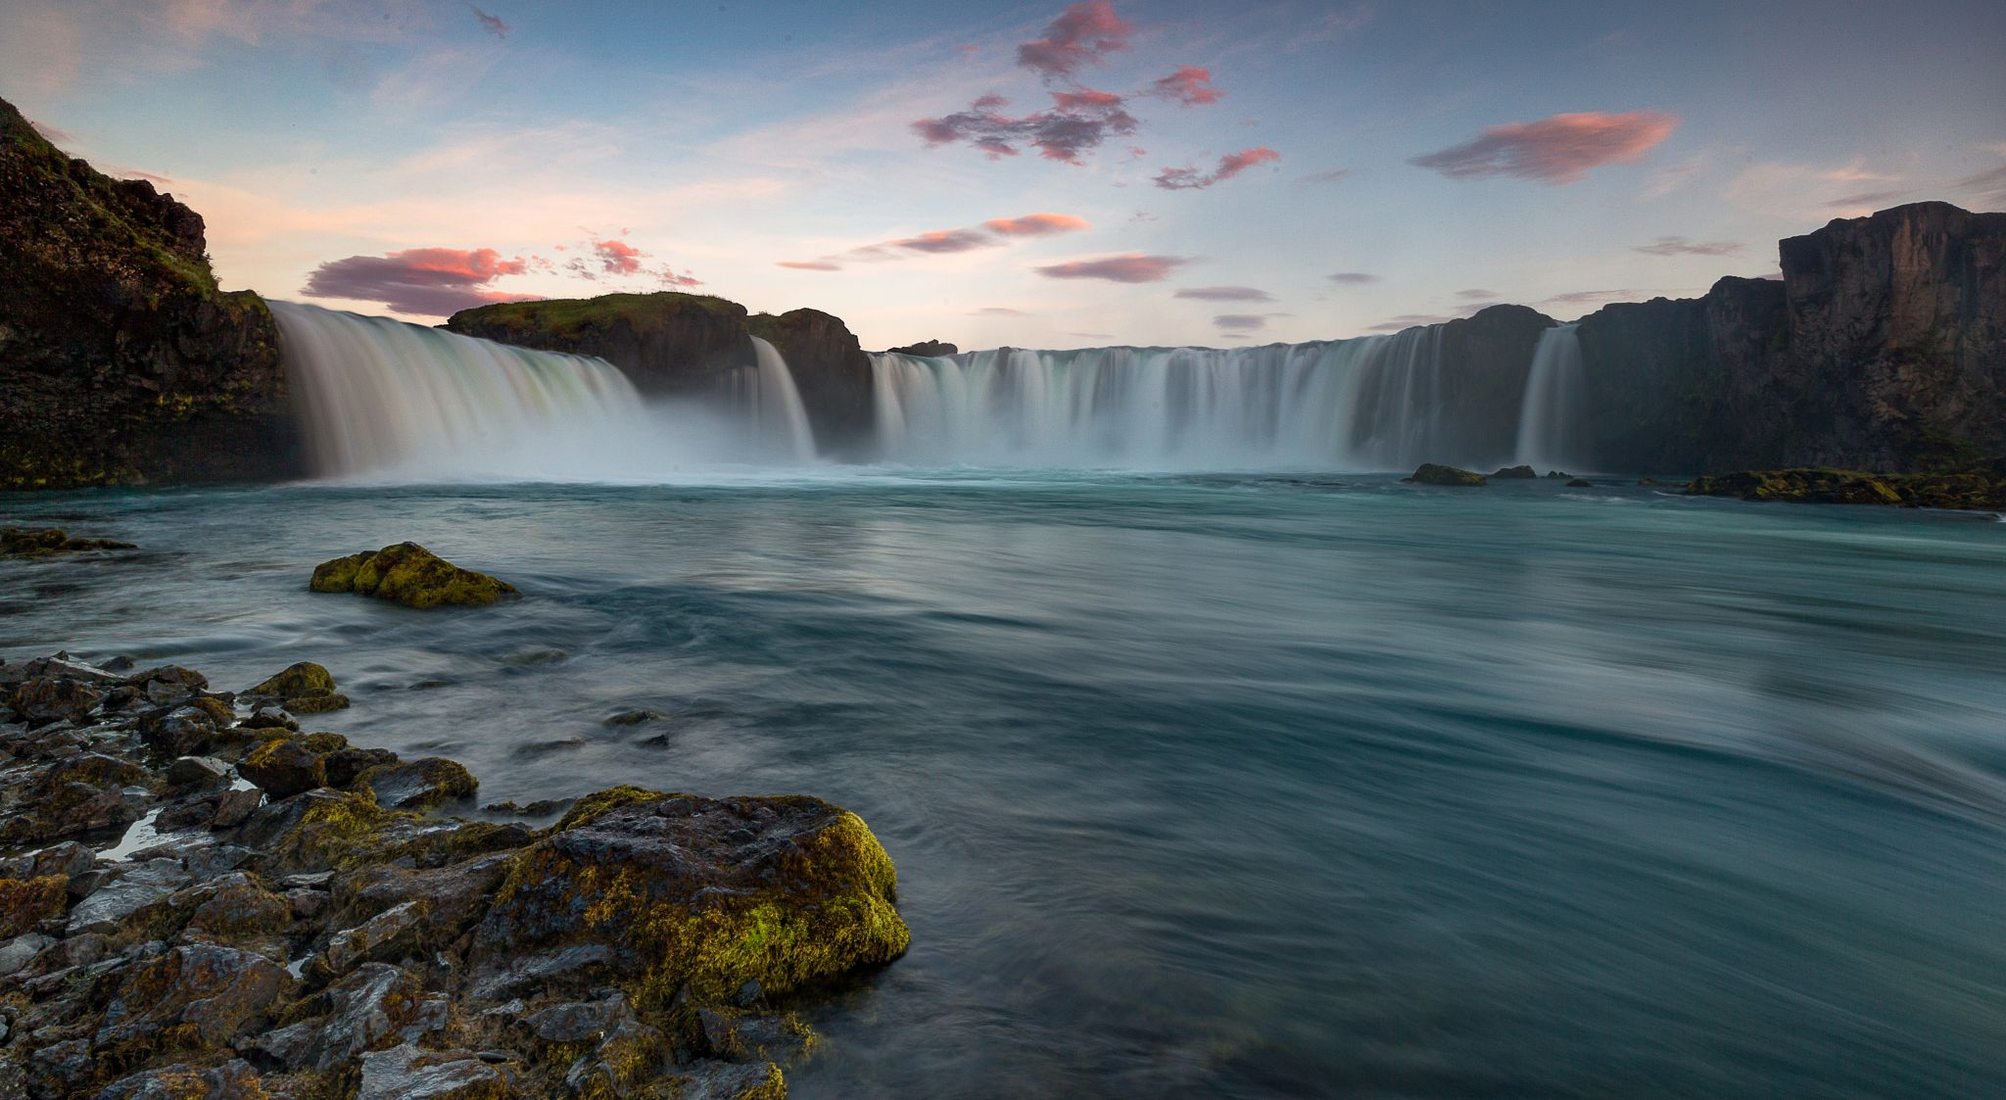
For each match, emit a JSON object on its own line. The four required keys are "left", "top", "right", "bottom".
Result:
{"left": 0, "top": 474, "right": 2006, "bottom": 1098}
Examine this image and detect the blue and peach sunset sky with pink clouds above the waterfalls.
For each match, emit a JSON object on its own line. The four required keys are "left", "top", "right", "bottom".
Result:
{"left": 0, "top": 0, "right": 2006, "bottom": 347}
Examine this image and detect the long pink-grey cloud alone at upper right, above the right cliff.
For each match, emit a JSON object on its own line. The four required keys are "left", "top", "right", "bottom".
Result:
{"left": 1410, "top": 110, "right": 1679, "bottom": 183}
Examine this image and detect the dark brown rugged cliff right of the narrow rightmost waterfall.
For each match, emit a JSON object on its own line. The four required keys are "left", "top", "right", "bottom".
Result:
{"left": 1581, "top": 203, "right": 2006, "bottom": 472}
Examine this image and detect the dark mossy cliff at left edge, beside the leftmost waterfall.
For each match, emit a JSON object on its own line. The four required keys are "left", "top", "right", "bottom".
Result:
{"left": 0, "top": 100, "right": 301, "bottom": 490}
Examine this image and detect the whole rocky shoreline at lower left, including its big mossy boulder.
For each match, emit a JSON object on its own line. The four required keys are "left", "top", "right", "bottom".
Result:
{"left": 0, "top": 638, "right": 909, "bottom": 1100}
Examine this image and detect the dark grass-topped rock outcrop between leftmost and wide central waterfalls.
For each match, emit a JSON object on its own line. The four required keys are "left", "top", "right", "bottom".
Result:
{"left": 445, "top": 291, "right": 873, "bottom": 454}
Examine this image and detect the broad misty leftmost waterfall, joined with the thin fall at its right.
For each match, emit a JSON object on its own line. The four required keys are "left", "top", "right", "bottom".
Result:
{"left": 271, "top": 301, "right": 814, "bottom": 482}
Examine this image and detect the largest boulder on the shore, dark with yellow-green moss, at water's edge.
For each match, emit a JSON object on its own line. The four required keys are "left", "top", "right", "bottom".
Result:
{"left": 475, "top": 789, "right": 911, "bottom": 1006}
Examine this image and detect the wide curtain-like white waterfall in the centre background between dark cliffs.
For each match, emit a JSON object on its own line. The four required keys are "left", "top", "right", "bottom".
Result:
{"left": 873, "top": 325, "right": 1509, "bottom": 470}
